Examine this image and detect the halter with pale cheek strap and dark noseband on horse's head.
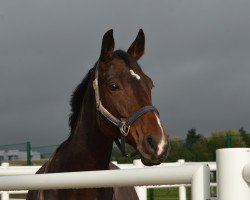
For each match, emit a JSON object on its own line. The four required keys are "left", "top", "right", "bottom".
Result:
{"left": 93, "top": 62, "right": 158, "bottom": 156}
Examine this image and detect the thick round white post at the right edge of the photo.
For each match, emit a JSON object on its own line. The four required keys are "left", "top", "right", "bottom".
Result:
{"left": 216, "top": 148, "right": 250, "bottom": 200}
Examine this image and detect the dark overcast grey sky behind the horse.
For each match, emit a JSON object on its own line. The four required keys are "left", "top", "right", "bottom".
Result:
{"left": 0, "top": 0, "right": 250, "bottom": 145}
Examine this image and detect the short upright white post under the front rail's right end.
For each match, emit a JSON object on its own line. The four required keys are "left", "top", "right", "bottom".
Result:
{"left": 191, "top": 165, "right": 210, "bottom": 200}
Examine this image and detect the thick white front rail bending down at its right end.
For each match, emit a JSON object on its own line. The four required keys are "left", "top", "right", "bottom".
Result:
{"left": 0, "top": 164, "right": 210, "bottom": 200}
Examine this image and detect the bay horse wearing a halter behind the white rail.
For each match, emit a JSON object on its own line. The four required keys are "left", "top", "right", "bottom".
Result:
{"left": 27, "top": 29, "right": 169, "bottom": 200}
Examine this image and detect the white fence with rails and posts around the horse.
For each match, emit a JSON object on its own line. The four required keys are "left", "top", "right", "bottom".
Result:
{"left": 0, "top": 148, "right": 250, "bottom": 200}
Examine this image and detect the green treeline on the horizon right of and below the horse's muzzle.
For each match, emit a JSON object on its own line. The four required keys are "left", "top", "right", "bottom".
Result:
{"left": 112, "top": 128, "right": 250, "bottom": 163}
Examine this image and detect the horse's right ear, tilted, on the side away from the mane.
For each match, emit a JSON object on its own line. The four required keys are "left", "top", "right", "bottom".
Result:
{"left": 127, "top": 29, "right": 145, "bottom": 60}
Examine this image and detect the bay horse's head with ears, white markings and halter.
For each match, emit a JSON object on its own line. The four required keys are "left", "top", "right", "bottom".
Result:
{"left": 93, "top": 29, "right": 169, "bottom": 165}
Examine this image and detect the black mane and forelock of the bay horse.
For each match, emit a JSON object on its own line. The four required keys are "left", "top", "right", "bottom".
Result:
{"left": 69, "top": 50, "right": 131, "bottom": 134}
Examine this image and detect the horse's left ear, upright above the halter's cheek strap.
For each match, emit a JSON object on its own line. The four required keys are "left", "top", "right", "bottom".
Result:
{"left": 99, "top": 29, "right": 115, "bottom": 61}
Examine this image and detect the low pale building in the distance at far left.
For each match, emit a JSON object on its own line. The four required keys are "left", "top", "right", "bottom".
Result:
{"left": 0, "top": 150, "right": 41, "bottom": 161}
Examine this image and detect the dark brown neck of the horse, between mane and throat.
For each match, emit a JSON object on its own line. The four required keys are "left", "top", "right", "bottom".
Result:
{"left": 51, "top": 83, "right": 113, "bottom": 171}
